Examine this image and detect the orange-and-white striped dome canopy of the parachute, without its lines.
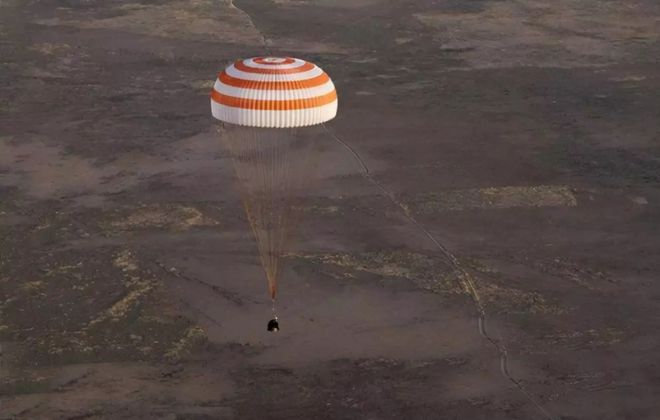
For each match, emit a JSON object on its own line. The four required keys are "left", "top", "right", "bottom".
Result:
{"left": 211, "top": 57, "right": 337, "bottom": 128}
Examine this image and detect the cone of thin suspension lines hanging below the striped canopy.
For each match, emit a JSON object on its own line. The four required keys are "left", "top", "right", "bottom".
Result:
{"left": 218, "top": 126, "right": 316, "bottom": 299}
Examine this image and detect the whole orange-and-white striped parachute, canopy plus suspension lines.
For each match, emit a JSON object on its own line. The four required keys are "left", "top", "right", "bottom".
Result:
{"left": 211, "top": 57, "right": 337, "bottom": 309}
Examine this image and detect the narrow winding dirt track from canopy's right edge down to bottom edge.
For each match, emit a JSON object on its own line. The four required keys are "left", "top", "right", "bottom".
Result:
{"left": 322, "top": 124, "right": 556, "bottom": 420}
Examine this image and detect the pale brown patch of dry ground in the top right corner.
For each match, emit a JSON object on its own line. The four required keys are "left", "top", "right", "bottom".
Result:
{"left": 415, "top": 0, "right": 659, "bottom": 68}
